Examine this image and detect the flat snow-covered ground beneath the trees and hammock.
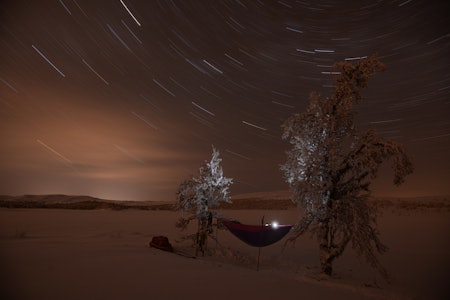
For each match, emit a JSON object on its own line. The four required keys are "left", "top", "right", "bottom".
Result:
{"left": 0, "top": 198, "right": 450, "bottom": 300}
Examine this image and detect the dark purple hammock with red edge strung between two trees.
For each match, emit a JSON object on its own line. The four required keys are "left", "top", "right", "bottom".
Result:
{"left": 222, "top": 221, "right": 292, "bottom": 247}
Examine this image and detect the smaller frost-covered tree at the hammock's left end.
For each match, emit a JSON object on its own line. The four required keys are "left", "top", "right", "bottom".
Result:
{"left": 176, "top": 147, "right": 233, "bottom": 255}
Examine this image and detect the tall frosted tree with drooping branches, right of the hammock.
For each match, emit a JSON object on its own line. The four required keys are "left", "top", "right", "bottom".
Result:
{"left": 281, "top": 56, "right": 413, "bottom": 278}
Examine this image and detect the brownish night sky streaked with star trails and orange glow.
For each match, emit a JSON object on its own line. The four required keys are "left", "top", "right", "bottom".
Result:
{"left": 0, "top": 0, "right": 450, "bottom": 201}
